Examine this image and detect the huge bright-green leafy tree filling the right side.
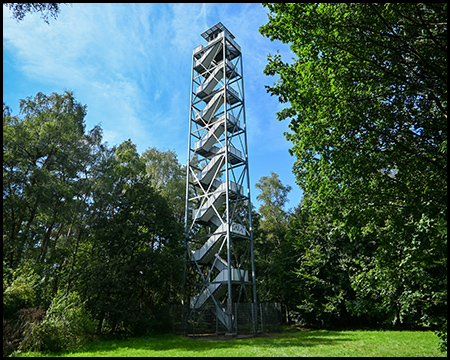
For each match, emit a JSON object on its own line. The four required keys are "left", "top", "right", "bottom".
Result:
{"left": 260, "top": 3, "right": 447, "bottom": 334}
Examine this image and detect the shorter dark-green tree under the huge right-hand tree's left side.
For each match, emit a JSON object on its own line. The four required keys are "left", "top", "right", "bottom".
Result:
{"left": 285, "top": 194, "right": 388, "bottom": 328}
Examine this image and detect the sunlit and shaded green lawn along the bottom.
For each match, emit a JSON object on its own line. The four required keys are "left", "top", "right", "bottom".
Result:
{"left": 14, "top": 329, "right": 447, "bottom": 357}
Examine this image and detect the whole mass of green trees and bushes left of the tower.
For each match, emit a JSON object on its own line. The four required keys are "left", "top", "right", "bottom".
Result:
{"left": 3, "top": 91, "right": 184, "bottom": 352}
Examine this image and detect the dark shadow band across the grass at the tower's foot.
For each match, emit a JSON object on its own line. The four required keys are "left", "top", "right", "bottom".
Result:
{"left": 73, "top": 330, "right": 353, "bottom": 356}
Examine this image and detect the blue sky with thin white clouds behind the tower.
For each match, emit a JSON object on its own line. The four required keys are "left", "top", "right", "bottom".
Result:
{"left": 3, "top": 3, "right": 302, "bottom": 208}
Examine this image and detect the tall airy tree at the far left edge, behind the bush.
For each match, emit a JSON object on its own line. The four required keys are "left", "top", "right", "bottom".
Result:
{"left": 3, "top": 91, "right": 101, "bottom": 351}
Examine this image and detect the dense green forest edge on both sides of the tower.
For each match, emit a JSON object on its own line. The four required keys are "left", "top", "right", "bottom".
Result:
{"left": 3, "top": 3, "right": 447, "bottom": 356}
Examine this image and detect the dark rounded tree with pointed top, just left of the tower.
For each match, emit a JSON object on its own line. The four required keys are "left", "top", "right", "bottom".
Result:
{"left": 75, "top": 140, "right": 183, "bottom": 334}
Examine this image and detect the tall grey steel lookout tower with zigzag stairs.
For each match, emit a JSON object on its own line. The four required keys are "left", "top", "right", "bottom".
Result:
{"left": 183, "top": 22, "right": 258, "bottom": 334}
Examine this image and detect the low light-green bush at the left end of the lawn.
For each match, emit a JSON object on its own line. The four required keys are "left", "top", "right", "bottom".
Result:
{"left": 19, "top": 293, "right": 95, "bottom": 352}
